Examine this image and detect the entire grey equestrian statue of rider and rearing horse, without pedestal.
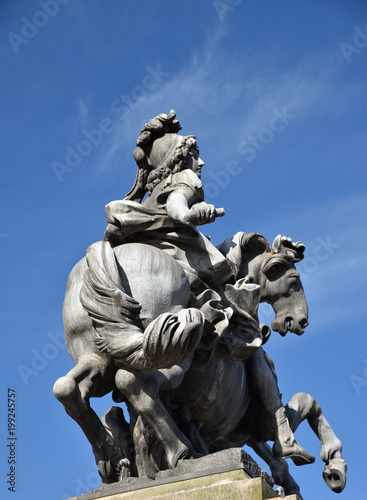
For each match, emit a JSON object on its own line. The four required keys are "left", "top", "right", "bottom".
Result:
{"left": 54, "top": 111, "right": 346, "bottom": 496}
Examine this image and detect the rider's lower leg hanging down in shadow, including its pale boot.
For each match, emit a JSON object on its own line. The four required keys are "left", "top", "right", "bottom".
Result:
{"left": 246, "top": 348, "right": 315, "bottom": 465}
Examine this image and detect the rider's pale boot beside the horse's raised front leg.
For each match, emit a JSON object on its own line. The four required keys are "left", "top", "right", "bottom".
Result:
{"left": 271, "top": 403, "right": 315, "bottom": 465}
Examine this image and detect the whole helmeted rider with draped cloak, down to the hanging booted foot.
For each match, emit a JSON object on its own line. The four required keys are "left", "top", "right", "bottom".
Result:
{"left": 105, "top": 111, "right": 314, "bottom": 465}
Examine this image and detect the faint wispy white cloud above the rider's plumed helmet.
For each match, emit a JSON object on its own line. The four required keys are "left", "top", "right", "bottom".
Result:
{"left": 96, "top": 23, "right": 356, "bottom": 177}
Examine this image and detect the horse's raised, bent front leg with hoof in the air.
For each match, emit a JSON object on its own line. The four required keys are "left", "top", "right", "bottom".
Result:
{"left": 285, "top": 392, "right": 347, "bottom": 493}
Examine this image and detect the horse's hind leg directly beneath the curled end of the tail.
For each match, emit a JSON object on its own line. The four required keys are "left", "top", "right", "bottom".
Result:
{"left": 115, "top": 368, "right": 194, "bottom": 468}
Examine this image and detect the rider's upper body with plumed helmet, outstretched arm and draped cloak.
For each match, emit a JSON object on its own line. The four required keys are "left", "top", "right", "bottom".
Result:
{"left": 105, "top": 114, "right": 232, "bottom": 293}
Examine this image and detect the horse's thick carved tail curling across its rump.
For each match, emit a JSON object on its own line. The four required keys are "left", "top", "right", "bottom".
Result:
{"left": 80, "top": 241, "right": 205, "bottom": 370}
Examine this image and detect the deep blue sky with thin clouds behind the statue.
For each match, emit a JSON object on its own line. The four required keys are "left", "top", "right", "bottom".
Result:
{"left": 0, "top": 0, "right": 367, "bottom": 500}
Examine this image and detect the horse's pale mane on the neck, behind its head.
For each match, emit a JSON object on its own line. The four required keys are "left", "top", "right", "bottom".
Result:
{"left": 217, "top": 231, "right": 272, "bottom": 279}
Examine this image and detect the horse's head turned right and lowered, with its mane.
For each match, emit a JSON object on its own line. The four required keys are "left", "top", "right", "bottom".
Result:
{"left": 218, "top": 232, "right": 308, "bottom": 336}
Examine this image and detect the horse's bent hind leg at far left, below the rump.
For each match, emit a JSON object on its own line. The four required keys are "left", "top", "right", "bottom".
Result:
{"left": 53, "top": 355, "right": 126, "bottom": 483}
